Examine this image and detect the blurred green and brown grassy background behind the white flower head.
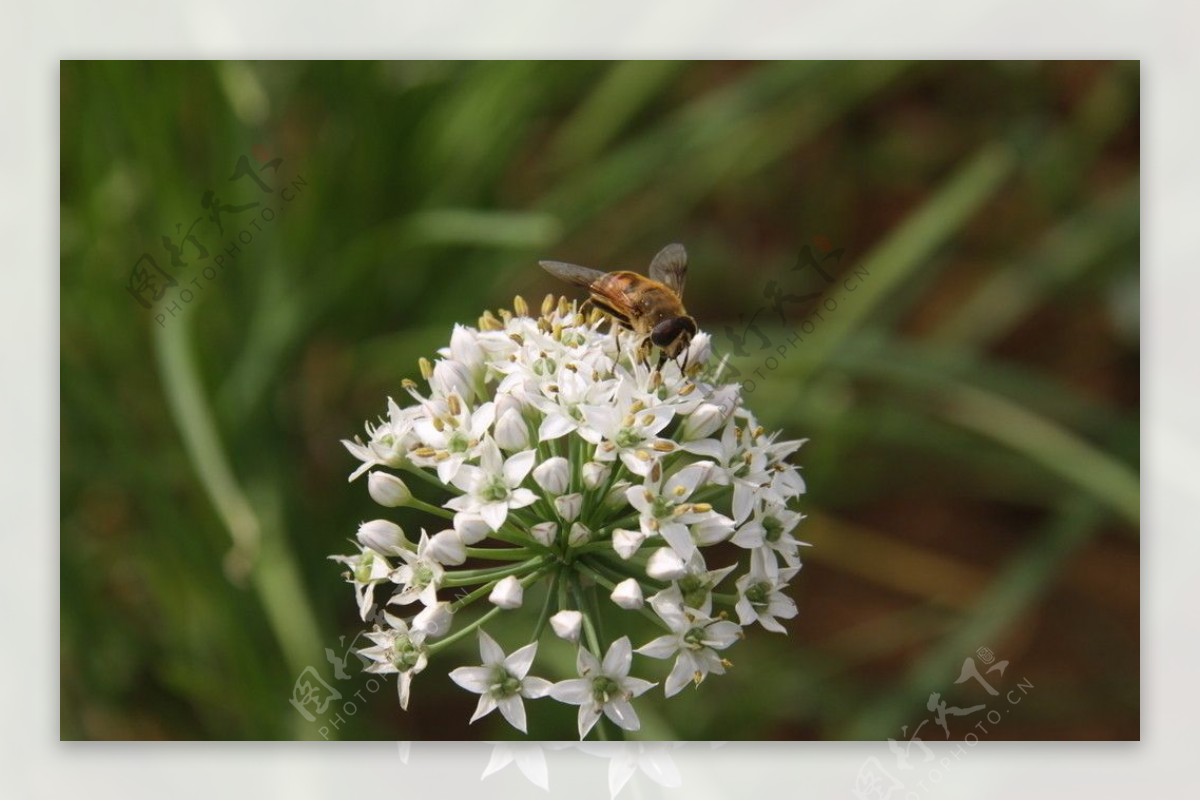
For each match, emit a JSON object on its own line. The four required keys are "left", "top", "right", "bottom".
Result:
{"left": 60, "top": 62, "right": 1140, "bottom": 740}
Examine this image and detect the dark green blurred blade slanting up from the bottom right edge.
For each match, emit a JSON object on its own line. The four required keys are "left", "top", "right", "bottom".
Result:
{"left": 835, "top": 498, "right": 1100, "bottom": 740}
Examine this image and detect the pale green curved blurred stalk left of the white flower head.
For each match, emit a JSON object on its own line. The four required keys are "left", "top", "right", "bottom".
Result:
{"left": 152, "top": 314, "right": 323, "bottom": 697}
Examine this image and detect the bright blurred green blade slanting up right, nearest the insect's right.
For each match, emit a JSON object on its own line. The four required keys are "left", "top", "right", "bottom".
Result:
{"left": 797, "top": 141, "right": 1016, "bottom": 375}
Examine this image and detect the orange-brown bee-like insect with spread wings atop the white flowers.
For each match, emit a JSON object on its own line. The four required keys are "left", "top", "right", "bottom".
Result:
{"left": 538, "top": 243, "right": 696, "bottom": 369}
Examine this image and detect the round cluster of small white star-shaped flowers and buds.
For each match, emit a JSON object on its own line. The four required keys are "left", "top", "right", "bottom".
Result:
{"left": 331, "top": 296, "right": 805, "bottom": 739}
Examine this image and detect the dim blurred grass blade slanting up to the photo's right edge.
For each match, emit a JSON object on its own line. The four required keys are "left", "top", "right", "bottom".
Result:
{"left": 929, "top": 177, "right": 1140, "bottom": 347}
